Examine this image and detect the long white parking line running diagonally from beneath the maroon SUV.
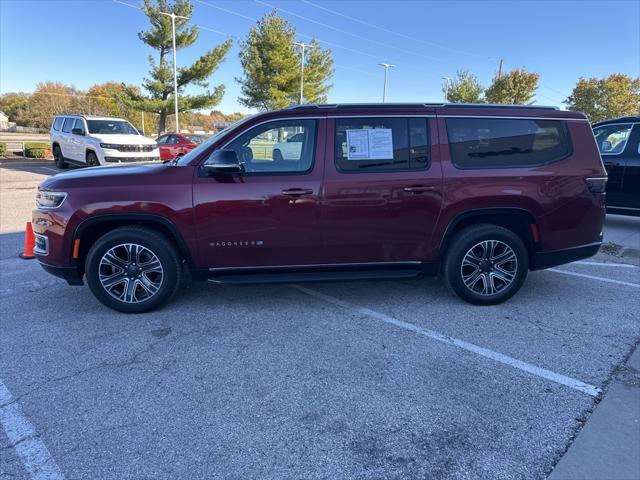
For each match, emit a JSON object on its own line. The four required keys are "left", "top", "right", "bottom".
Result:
{"left": 291, "top": 285, "right": 600, "bottom": 397}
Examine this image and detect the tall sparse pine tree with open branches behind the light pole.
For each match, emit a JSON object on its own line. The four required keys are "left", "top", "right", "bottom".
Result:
{"left": 131, "top": 0, "right": 231, "bottom": 132}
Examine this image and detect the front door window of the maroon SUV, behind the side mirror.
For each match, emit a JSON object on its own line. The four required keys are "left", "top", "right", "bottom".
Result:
{"left": 226, "top": 120, "right": 316, "bottom": 173}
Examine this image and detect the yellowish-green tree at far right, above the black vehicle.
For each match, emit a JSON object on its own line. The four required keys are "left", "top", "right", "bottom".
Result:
{"left": 564, "top": 73, "right": 640, "bottom": 123}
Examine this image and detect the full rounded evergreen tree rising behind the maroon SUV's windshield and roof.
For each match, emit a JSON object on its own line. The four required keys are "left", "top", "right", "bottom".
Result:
{"left": 236, "top": 10, "right": 333, "bottom": 110}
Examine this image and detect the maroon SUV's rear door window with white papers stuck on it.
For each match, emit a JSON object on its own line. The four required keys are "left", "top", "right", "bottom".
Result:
{"left": 335, "top": 118, "right": 429, "bottom": 172}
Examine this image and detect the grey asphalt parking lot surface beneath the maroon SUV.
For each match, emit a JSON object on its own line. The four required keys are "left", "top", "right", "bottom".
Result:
{"left": 0, "top": 161, "right": 640, "bottom": 479}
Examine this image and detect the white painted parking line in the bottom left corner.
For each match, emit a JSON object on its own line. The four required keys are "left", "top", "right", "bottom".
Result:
{"left": 0, "top": 380, "right": 64, "bottom": 480}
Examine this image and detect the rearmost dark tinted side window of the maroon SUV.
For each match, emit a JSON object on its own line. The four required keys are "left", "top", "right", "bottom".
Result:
{"left": 446, "top": 118, "right": 570, "bottom": 168}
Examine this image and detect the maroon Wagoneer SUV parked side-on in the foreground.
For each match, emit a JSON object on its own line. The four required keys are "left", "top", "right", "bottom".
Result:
{"left": 33, "top": 104, "right": 607, "bottom": 312}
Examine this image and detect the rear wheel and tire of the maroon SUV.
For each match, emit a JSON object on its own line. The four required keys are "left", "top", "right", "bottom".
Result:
{"left": 443, "top": 224, "right": 529, "bottom": 305}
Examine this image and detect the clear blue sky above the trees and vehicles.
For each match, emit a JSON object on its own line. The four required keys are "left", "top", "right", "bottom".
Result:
{"left": 0, "top": 0, "right": 640, "bottom": 113}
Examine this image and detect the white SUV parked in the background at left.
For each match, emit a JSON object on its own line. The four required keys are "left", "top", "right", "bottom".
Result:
{"left": 50, "top": 115, "right": 160, "bottom": 168}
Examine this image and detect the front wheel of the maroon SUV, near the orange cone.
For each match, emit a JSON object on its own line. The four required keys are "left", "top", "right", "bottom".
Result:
{"left": 85, "top": 227, "right": 182, "bottom": 313}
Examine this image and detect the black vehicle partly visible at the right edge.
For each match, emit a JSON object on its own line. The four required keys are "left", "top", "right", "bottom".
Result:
{"left": 593, "top": 116, "right": 640, "bottom": 216}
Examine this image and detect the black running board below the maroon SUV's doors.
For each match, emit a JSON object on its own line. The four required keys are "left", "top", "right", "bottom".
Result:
{"left": 209, "top": 268, "right": 423, "bottom": 285}
